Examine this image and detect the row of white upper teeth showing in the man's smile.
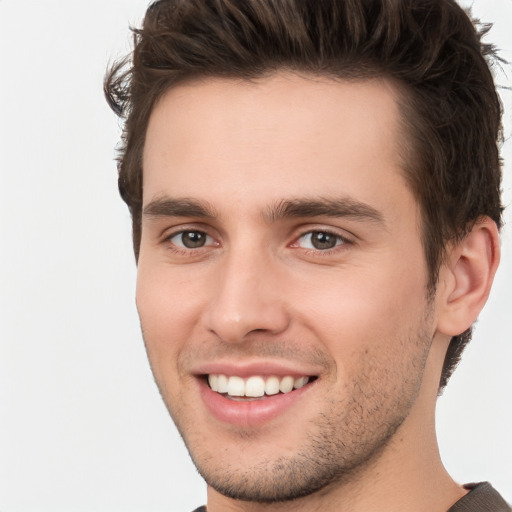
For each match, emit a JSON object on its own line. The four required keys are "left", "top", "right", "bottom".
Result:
{"left": 208, "top": 374, "right": 309, "bottom": 398}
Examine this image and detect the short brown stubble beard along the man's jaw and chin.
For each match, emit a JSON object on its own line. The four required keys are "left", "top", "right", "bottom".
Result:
{"left": 152, "top": 307, "right": 432, "bottom": 504}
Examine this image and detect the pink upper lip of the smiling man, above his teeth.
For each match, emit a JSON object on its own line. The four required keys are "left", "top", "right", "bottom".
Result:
{"left": 192, "top": 361, "right": 319, "bottom": 378}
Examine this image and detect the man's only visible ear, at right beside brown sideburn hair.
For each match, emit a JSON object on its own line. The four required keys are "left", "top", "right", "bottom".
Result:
{"left": 436, "top": 217, "right": 500, "bottom": 336}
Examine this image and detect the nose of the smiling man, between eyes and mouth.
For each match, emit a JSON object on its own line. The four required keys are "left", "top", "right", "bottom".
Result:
{"left": 206, "top": 252, "right": 290, "bottom": 343}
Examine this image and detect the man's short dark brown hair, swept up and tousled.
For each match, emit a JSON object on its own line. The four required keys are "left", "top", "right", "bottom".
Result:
{"left": 105, "top": 0, "right": 502, "bottom": 388}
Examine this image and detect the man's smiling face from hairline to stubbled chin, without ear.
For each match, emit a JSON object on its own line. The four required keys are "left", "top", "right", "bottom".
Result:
{"left": 137, "top": 74, "right": 435, "bottom": 502}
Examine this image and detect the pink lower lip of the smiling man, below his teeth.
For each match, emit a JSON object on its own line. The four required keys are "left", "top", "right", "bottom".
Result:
{"left": 200, "top": 379, "right": 316, "bottom": 427}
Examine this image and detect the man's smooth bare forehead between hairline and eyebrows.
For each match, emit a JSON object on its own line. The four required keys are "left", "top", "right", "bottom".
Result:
{"left": 143, "top": 73, "right": 405, "bottom": 214}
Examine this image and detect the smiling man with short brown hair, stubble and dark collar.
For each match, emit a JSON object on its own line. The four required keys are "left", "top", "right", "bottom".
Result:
{"left": 106, "top": 0, "right": 510, "bottom": 512}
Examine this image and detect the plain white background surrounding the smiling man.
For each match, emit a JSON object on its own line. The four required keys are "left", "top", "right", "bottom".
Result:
{"left": 0, "top": 0, "right": 512, "bottom": 512}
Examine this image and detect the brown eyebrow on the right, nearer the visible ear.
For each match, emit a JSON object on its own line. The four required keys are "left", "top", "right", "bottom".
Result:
{"left": 264, "top": 197, "right": 385, "bottom": 225}
